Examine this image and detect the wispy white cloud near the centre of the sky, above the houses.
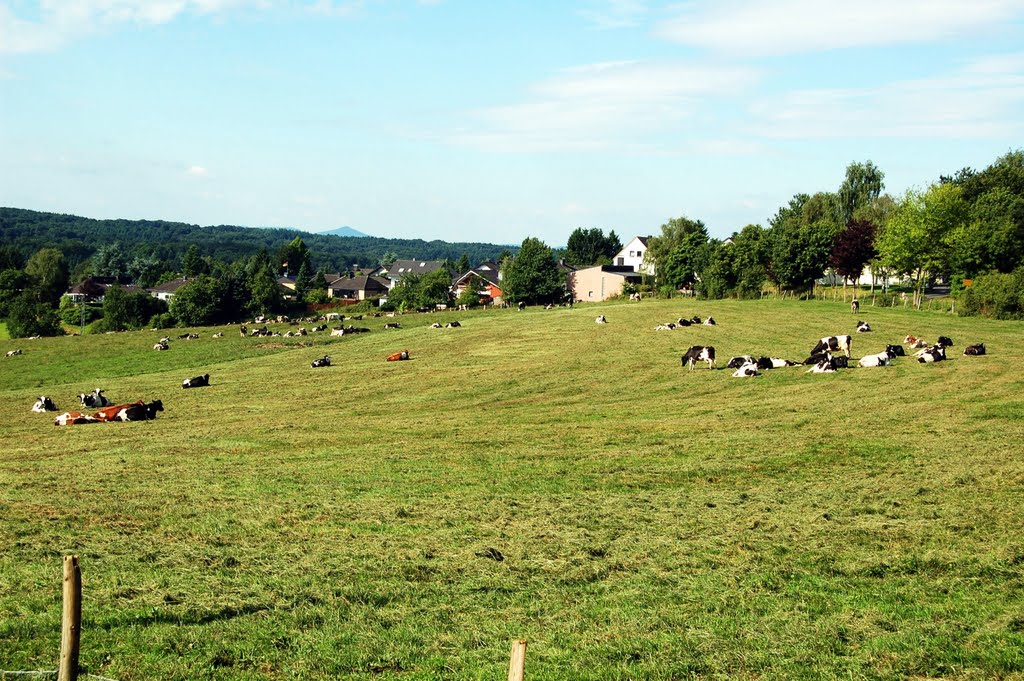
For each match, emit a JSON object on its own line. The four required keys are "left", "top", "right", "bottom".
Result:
{"left": 451, "top": 61, "right": 756, "bottom": 151}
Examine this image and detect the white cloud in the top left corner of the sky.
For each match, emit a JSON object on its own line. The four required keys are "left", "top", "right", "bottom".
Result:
{"left": 0, "top": 0, "right": 270, "bottom": 54}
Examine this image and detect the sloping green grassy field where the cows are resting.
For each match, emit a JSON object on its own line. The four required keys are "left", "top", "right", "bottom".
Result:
{"left": 0, "top": 300, "right": 1024, "bottom": 681}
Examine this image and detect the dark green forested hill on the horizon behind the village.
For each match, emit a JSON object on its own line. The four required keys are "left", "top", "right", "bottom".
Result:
{"left": 0, "top": 208, "right": 515, "bottom": 271}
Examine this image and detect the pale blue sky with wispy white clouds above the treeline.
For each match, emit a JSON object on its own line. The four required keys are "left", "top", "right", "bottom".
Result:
{"left": 0, "top": 0, "right": 1024, "bottom": 246}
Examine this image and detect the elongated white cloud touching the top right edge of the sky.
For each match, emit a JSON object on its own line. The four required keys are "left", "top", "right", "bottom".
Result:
{"left": 656, "top": 0, "right": 1024, "bottom": 55}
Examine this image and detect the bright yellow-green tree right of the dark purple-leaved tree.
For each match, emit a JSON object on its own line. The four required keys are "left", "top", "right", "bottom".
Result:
{"left": 874, "top": 183, "right": 968, "bottom": 309}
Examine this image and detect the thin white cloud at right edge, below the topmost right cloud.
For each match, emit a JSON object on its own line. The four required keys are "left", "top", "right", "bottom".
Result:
{"left": 752, "top": 54, "right": 1024, "bottom": 139}
